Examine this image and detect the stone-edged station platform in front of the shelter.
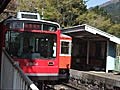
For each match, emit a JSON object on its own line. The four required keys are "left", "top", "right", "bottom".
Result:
{"left": 70, "top": 69, "right": 120, "bottom": 88}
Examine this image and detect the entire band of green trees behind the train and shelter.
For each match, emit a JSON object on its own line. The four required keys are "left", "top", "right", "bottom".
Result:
{"left": 1, "top": 0, "right": 120, "bottom": 37}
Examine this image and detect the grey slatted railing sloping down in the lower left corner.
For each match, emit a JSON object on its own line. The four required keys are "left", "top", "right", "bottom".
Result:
{"left": 0, "top": 49, "right": 39, "bottom": 90}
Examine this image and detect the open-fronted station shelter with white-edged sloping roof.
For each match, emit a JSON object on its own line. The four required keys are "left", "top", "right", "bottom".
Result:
{"left": 62, "top": 24, "right": 120, "bottom": 72}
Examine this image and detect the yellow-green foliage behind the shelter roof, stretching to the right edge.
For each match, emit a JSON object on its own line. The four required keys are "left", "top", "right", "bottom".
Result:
{"left": 77, "top": 7, "right": 120, "bottom": 37}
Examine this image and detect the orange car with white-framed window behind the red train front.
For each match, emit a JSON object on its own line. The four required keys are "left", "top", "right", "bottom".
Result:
{"left": 59, "top": 34, "right": 72, "bottom": 80}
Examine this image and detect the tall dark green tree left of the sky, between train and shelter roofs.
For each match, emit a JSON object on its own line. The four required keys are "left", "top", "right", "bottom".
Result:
{"left": 54, "top": 0, "right": 87, "bottom": 27}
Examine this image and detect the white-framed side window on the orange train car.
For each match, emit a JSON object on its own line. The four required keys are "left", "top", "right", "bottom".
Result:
{"left": 61, "top": 41, "right": 70, "bottom": 54}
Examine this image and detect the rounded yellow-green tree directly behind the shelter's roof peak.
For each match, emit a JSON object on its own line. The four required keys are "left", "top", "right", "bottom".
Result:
{"left": 77, "top": 7, "right": 112, "bottom": 32}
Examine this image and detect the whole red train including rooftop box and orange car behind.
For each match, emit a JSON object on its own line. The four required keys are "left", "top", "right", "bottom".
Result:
{"left": 1, "top": 12, "right": 71, "bottom": 80}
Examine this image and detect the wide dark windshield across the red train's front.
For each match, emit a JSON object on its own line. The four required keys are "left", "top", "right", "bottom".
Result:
{"left": 5, "top": 31, "right": 57, "bottom": 59}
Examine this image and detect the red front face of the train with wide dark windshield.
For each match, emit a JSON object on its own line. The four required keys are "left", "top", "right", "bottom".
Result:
{"left": 5, "top": 11, "right": 60, "bottom": 80}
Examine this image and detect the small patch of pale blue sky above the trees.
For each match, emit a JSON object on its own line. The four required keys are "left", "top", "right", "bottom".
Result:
{"left": 84, "top": 0, "right": 110, "bottom": 8}
